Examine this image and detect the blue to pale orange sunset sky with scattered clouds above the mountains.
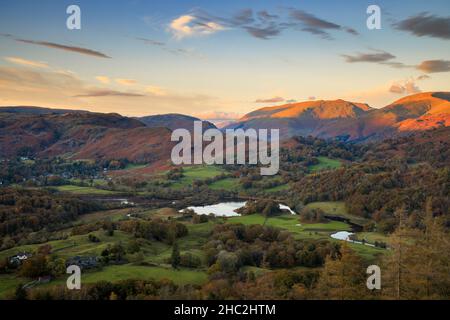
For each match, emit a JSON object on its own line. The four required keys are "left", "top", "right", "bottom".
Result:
{"left": 0, "top": 0, "right": 450, "bottom": 119}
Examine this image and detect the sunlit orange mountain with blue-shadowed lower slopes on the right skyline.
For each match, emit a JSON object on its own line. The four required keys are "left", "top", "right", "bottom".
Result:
{"left": 228, "top": 92, "right": 450, "bottom": 141}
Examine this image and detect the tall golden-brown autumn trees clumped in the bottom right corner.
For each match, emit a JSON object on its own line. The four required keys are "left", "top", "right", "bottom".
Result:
{"left": 382, "top": 206, "right": 450, "bottom": 299}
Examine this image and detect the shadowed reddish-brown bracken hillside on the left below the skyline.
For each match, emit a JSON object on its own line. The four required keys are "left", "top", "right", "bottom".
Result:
{"left": 0, "top": 108, "right": 171, "bottom": 162}
